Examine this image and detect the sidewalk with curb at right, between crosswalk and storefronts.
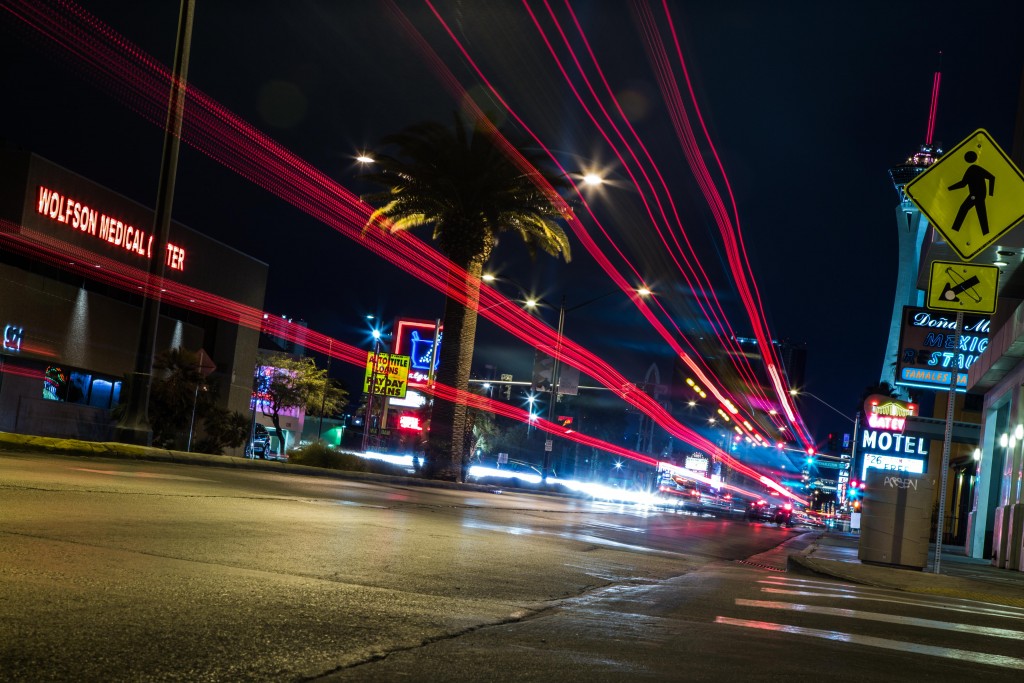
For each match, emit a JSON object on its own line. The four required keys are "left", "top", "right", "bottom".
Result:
{"left": 787, "top": 531, "right": 1024, "bottom": 608}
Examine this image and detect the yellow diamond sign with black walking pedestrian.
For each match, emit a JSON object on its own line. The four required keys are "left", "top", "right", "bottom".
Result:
{"left": 903, "top": 129, "right": 1024, "bottom": 261}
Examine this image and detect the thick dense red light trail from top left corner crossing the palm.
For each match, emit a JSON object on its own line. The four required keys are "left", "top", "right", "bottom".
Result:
{"left": 9, "top": 0, "right": 811, "bottom": 501}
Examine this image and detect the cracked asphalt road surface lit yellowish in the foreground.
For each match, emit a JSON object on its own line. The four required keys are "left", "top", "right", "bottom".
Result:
{"left": 0, "top": 455, "right": 1024, "bottom": 681}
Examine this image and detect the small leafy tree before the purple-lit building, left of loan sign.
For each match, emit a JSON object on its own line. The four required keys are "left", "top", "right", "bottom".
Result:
{"left": 257, "top": 353, "right": 348, "bottom": 449}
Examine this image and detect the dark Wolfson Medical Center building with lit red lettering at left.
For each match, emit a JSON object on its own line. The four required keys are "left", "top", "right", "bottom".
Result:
{"left": 0, "top": 147, "right": 267, "bottom": 439}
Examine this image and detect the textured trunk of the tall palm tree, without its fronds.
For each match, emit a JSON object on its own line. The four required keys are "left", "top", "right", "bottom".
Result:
{"left": 427, "top": 259, "right": 483, "bottom": 481}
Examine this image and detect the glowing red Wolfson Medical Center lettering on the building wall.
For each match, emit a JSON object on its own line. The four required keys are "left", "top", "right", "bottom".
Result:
{"left": 36, "top": 185, "right": 185, "bottom": 271}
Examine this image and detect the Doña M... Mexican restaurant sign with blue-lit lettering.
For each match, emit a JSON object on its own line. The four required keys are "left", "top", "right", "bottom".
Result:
{"left": 896, "top": 306, "right": 989, "bottom": 392}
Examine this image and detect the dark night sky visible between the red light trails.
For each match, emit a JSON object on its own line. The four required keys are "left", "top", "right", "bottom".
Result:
{"left": 0, "top": 0, "right": 1024, "bottom": 458}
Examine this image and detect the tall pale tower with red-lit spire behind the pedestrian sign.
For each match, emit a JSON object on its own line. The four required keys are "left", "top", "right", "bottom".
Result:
{"left": 880, "top": 72, "right": 942, "bottom": 398}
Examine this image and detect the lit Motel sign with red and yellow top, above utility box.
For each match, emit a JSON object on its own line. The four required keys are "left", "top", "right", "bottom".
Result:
{"left": 858, "top": 394, "right": 929, "bottom": 479}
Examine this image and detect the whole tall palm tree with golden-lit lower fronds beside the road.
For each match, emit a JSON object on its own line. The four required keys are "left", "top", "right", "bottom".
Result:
{"left": 365, "top": 117, "right": 570, "bottom": 481}
